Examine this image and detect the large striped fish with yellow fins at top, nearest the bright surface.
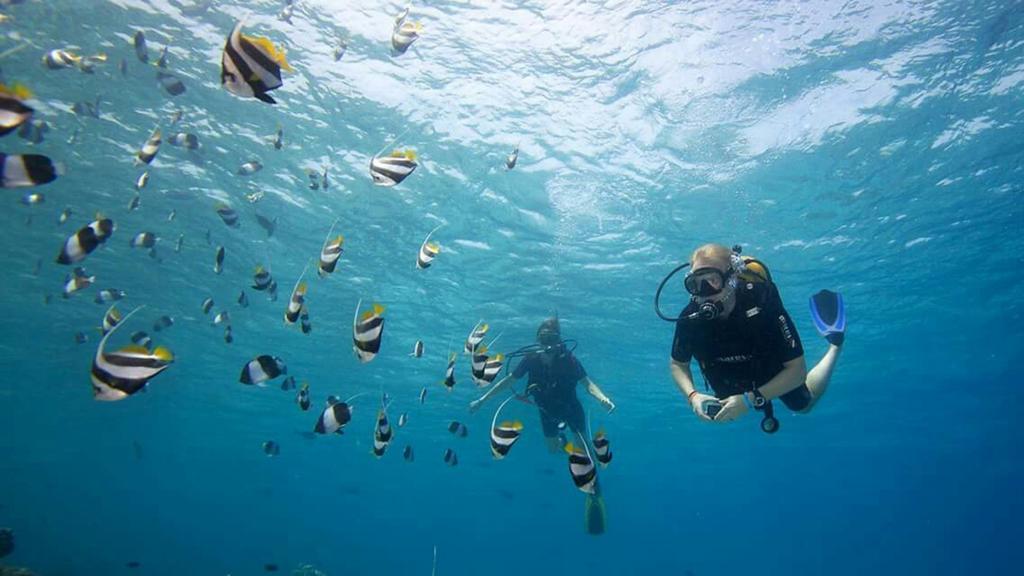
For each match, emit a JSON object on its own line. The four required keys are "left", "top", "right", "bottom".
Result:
{"left": 220, "top": 22, "right": 292, "bottom": 104}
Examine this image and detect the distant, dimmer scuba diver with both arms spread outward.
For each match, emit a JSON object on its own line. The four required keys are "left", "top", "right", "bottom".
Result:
{"left": 469, "top": 318, "right": 615, "bottom": 453}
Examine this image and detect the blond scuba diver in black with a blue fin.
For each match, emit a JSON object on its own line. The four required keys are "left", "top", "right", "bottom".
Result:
{"left": 655, "top": 244, "right": 846, "bottom": 434}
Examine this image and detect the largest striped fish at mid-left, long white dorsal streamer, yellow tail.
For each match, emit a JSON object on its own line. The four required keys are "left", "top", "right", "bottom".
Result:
{"left": 90, "top": 308, "right": 174, "bottom": 402}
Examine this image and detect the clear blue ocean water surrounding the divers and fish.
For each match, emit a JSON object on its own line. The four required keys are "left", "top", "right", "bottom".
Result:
{"left": 0, "top": 0, "right": 1024, "bottom": 576}
